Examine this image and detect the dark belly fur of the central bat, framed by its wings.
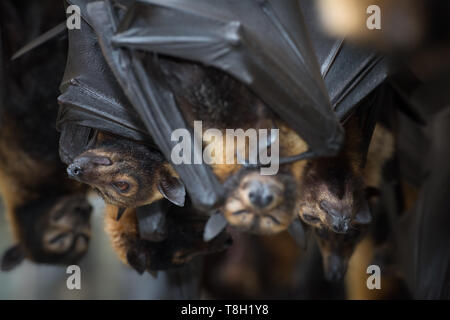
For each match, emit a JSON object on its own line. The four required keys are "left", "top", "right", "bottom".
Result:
{"left": 156, "top": 56, "right": 274, "bottom": 129}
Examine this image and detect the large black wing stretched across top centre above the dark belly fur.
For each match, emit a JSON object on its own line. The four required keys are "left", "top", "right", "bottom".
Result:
{"left": 104, "top": 0, "right": 342, "bottom": 156}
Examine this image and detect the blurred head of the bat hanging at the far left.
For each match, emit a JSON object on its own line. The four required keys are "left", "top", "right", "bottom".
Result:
{"left": 1, "top": 194, "right": 92, "bottom": 271}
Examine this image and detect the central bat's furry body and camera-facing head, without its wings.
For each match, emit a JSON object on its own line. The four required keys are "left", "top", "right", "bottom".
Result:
{"left": 153, "top": 57, "right": 307, "bottom": 234}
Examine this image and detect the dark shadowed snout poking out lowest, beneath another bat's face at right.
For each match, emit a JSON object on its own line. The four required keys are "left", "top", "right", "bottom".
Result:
{"left": 314, "top": 226, "right": 367, "bottom": 281}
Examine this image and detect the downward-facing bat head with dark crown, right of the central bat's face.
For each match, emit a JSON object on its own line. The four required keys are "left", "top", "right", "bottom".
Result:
{"left": 298, "top": 158, "right": 371, "bottom": 233}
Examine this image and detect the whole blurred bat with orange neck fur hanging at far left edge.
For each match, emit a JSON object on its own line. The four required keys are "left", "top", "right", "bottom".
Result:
{"left": 0, "top": 1, "right": 91, "bottom": 271}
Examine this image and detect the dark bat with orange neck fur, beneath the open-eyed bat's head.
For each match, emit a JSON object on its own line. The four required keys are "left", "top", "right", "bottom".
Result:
{"left": 105, "top": 199, "right": 231, "bottom": 273}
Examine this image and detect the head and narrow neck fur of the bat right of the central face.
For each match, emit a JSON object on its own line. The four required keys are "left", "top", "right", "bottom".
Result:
{"left": 298, "top": 119, "right": 367, "bottom": 232}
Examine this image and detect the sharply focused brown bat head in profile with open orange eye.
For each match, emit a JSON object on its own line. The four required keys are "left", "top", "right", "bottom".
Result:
{"left": 67, "top": 137, "right": 185, "bottom": 208}
